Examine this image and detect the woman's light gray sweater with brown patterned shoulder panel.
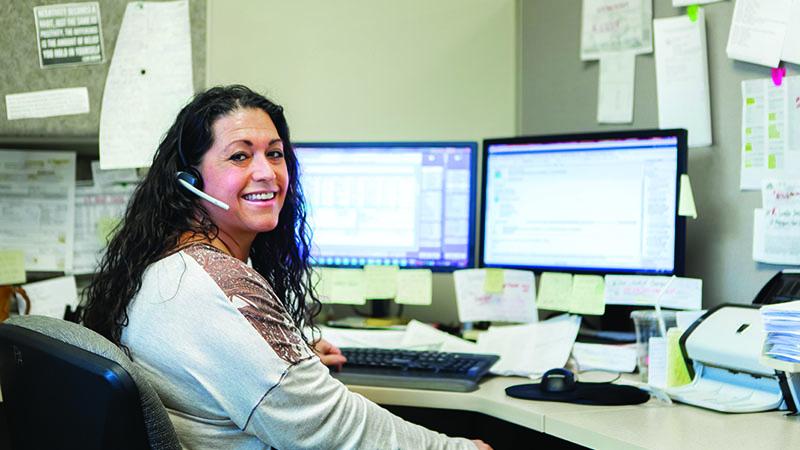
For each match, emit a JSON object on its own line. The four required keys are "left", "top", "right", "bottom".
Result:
{"left": 122, "top": 245, "right": 475, "bottom": 450}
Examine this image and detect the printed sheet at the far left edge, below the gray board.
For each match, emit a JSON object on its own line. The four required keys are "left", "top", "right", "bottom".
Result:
{"left": 0, "top": 150, "right": 75, "bottom": 272}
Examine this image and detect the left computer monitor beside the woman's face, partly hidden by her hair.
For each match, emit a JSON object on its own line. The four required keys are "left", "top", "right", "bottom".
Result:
{"left": 294, "top": 142, "right": 477, "bottom": 271}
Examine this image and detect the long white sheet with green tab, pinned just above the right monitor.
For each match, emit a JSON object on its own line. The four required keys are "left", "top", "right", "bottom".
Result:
{"left": 653, "top": 9, "right": 711, "bottom": 147}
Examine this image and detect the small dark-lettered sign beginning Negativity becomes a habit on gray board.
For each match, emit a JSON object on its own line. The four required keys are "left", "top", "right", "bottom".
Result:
{"left": 33, "top": 2, "right": 105, "bottom": 69}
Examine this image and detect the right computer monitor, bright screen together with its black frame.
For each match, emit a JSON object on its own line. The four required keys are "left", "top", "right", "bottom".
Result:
{"left": 479, "top": 130, "right": 686, "bottom": 275}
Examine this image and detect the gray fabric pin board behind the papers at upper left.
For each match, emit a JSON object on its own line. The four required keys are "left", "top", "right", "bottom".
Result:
{"left": 0, "top": 0, "right": 206, "bottom": 137}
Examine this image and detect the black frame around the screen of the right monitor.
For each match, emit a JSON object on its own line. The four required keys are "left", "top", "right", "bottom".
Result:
{"left": 477, "top": 128, "right": 688, "bottom": 276}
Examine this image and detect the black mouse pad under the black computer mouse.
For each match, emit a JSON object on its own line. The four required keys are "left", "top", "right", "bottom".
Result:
{"left": 506, "top": 381, "right": 650, "bottom": 406}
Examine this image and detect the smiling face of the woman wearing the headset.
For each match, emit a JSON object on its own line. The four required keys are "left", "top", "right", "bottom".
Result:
{"left": 199, "top": 108, "right": 289, "bottom": 245}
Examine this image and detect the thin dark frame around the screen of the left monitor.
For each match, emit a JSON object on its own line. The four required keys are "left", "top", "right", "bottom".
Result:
{"left": 292, "top": 141, "right": 478, "bottom": 273}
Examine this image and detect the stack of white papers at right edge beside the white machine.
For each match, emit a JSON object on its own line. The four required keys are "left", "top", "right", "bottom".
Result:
{"left": 761, "top": 300, "right": 800, "bottom": 363}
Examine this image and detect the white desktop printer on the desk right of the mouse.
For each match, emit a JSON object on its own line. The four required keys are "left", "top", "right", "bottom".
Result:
{"left": 666, "top": 304, "right": 785, "bottom": 413}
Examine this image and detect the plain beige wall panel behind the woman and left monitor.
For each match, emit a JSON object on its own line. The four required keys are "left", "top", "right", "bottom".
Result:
{"left": 206, "top": 0, "right": 518, "bottom": 322}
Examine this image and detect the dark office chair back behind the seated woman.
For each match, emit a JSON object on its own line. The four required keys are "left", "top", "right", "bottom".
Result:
{"left": 0, "top": 316, "right": 181, "bottom": 449}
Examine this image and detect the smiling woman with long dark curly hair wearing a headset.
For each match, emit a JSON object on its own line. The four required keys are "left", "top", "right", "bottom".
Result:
{"left": 84, "top": 86, "right": 488, "bottom": 449}
